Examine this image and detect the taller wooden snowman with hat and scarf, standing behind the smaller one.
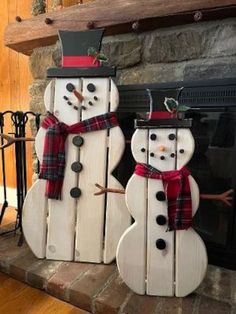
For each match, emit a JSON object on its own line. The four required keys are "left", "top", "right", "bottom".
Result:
{"left": 23, "top": 30, "right": 130, "bottom": 263}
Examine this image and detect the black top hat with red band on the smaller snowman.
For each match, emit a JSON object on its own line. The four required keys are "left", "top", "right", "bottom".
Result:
{"left": 135, "top": 88, "right": 192, "bottom": 129}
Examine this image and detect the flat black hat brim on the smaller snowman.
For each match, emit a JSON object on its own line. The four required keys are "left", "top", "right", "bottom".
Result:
{"left": 135, "top": 119, "right": 192, "bottom": 129}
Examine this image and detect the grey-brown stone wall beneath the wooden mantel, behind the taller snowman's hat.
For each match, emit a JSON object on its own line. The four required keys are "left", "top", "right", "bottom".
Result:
{"left": 29, "top": 18, "right": 236, "bottom": 113}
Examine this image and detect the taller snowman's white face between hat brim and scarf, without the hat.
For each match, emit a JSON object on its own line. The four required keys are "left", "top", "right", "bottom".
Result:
{"left": 44, "top": 77, "right": 119, "bottom": 124}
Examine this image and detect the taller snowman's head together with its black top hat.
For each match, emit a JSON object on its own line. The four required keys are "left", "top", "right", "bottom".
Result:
{"left": 45, "top": 29, "right": 115, "bottom": 123}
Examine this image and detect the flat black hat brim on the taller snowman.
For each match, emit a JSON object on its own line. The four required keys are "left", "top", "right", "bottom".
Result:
{"left": 47, "top": 66, "right": 116, "bottom": 77}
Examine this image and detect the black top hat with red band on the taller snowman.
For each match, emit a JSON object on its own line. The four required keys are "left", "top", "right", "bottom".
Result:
{"left": 47, "top": 29, "right": 116, "bottom": 77}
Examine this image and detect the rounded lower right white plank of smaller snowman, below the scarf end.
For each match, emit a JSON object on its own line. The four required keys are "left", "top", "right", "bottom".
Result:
{"left": 175, "top": 228, "right": 207, "bottom": 297}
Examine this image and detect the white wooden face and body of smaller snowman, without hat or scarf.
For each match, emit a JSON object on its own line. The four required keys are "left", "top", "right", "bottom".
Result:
{"left": 117, "top": 128, "right": 207, "bottom": 297}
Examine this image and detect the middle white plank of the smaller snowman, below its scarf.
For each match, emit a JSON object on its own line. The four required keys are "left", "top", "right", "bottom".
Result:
{"left": 147, "top": 179, "right": 174, "bottom": 296}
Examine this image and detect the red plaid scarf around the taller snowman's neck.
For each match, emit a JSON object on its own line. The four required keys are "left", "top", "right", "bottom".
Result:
{"left": 39, "top": 112, "right": 118, "bottom": 199}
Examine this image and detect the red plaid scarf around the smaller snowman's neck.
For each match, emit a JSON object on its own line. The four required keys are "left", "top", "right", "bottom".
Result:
{"left": 135, "top": 164, "right": 192, "bottom": 231}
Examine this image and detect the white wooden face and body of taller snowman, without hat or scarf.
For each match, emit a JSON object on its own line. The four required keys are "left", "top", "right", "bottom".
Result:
{"left": 23, "top": 77, "right": 130, "bottom": 263}
